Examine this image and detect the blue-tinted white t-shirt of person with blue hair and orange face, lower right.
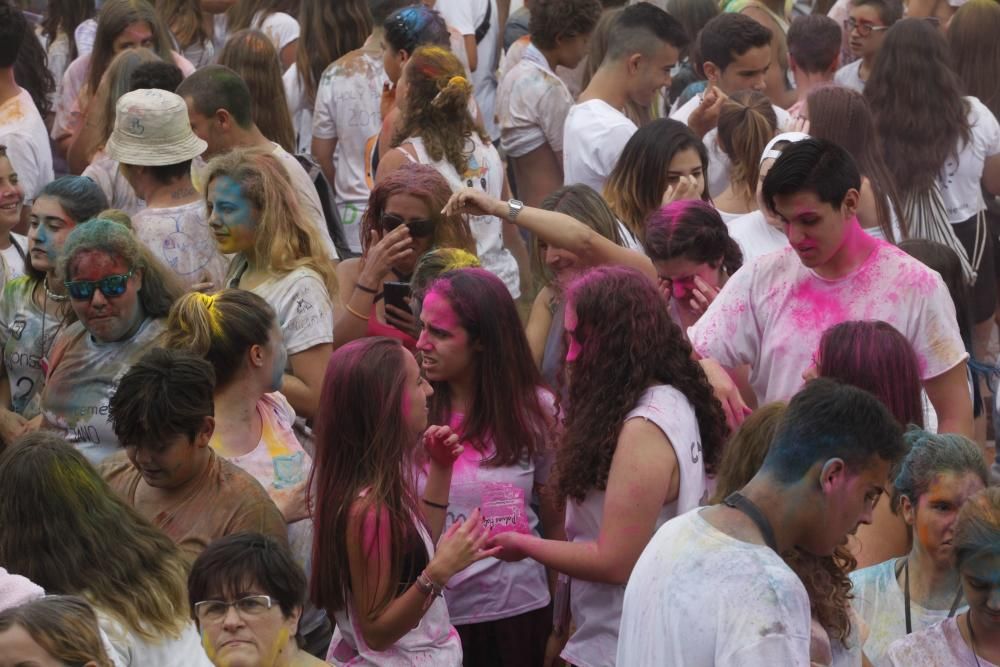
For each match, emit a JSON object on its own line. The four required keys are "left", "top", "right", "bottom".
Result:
{"left": 850, "top": 559, "right": 968, "bottom": 667}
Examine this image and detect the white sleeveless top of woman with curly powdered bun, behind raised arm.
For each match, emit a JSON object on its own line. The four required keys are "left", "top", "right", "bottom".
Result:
{"left": 403, "top": 134, "right": 521, "bottom": 299}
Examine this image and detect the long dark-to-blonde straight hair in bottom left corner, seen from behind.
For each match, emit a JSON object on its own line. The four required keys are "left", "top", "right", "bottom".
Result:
{"left": 0, "top": 431, "right": 191, "bottom": 642}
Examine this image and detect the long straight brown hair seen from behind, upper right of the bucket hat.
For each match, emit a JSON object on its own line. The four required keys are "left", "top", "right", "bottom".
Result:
{"left": 218, "top": 30, "right": 295, "bottom": 153}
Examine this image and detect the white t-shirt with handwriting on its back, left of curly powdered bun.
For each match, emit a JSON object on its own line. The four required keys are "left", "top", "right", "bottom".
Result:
{"left": 312, "top": 38, "right": 389, "bottom": 252}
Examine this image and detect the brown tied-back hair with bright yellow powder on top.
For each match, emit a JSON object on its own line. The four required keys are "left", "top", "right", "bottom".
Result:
{"left": 161, "top": 289, "right": 276, "bottom": 387}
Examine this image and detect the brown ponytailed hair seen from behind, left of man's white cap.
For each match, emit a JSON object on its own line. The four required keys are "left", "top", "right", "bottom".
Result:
{"left": 719, "top": 90, "right": 778, "bottom": 194}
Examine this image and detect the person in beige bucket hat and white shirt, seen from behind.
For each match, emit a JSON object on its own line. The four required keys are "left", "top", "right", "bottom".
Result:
{"left": 105, "top": 89, "right": 228, "bottom": 291}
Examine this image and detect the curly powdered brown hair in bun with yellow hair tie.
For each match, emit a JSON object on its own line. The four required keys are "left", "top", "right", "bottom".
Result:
{"left": 392, "top": 46, "right": 490, "bottom": 175}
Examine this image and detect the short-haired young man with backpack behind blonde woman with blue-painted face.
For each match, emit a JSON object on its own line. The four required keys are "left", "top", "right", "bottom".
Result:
{"left": 177, "top": 65, "right": 338, "bottom": 260}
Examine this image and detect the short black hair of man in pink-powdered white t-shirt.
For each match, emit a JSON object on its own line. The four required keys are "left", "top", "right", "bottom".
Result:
{"left": 763, "top": 139, "right": 861, "bottom": 211}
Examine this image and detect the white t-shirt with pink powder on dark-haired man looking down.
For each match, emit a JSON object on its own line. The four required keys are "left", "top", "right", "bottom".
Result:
{"left": 688, "top": 242, "right": 968, "bottom": 405}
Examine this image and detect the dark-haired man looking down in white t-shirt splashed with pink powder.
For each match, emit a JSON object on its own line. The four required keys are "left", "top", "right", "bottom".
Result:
{"left": 688, "top": 139, "right": 973, "bottom": 437}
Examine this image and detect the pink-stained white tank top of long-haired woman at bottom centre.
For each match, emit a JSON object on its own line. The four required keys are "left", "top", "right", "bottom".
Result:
{"left": 326, "top": 518, "right": 462, "bottom": 667}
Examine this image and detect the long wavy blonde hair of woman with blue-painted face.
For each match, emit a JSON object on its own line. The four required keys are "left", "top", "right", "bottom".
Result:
{"left": 205, "top": 148, "right": 337, "bottom": 298}
